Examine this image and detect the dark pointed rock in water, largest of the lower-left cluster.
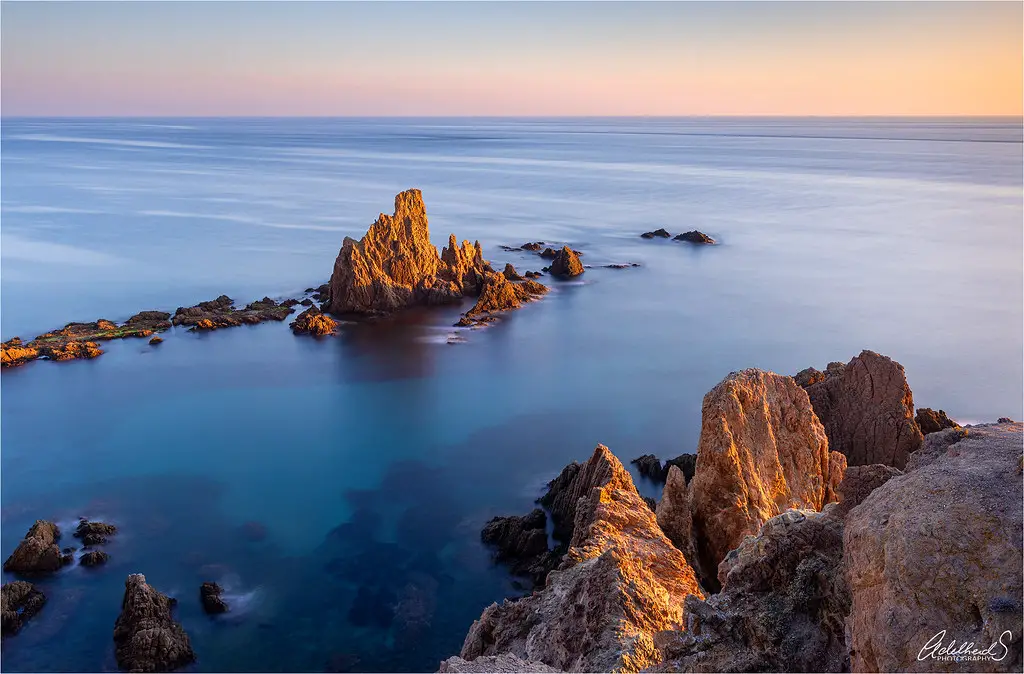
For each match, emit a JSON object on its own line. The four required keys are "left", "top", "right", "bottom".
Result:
{"left": 114, "top": 574, "right": 196, "bottom": 672}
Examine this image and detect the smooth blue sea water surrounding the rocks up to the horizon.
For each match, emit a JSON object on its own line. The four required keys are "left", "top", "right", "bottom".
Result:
{"left": 0, "top": 119, "right": 1024, "bottom": 671}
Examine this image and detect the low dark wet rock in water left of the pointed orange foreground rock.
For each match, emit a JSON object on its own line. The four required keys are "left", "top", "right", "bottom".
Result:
{"left": 480, "top": 508, "right": 561, "bottom": 586}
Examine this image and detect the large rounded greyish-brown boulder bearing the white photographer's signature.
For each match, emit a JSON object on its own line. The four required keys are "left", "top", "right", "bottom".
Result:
{"left": 844, "top": 424, "right": 1024, "bottom": 672}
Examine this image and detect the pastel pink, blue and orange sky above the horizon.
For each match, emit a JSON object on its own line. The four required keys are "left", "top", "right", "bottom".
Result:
{"left": 0, "top": 2, "right": 1024, "bottom": 116}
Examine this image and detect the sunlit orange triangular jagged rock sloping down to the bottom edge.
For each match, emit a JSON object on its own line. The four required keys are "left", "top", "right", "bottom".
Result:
{"left": 460, "top": 446, "right": 702, "bottom": 672}
